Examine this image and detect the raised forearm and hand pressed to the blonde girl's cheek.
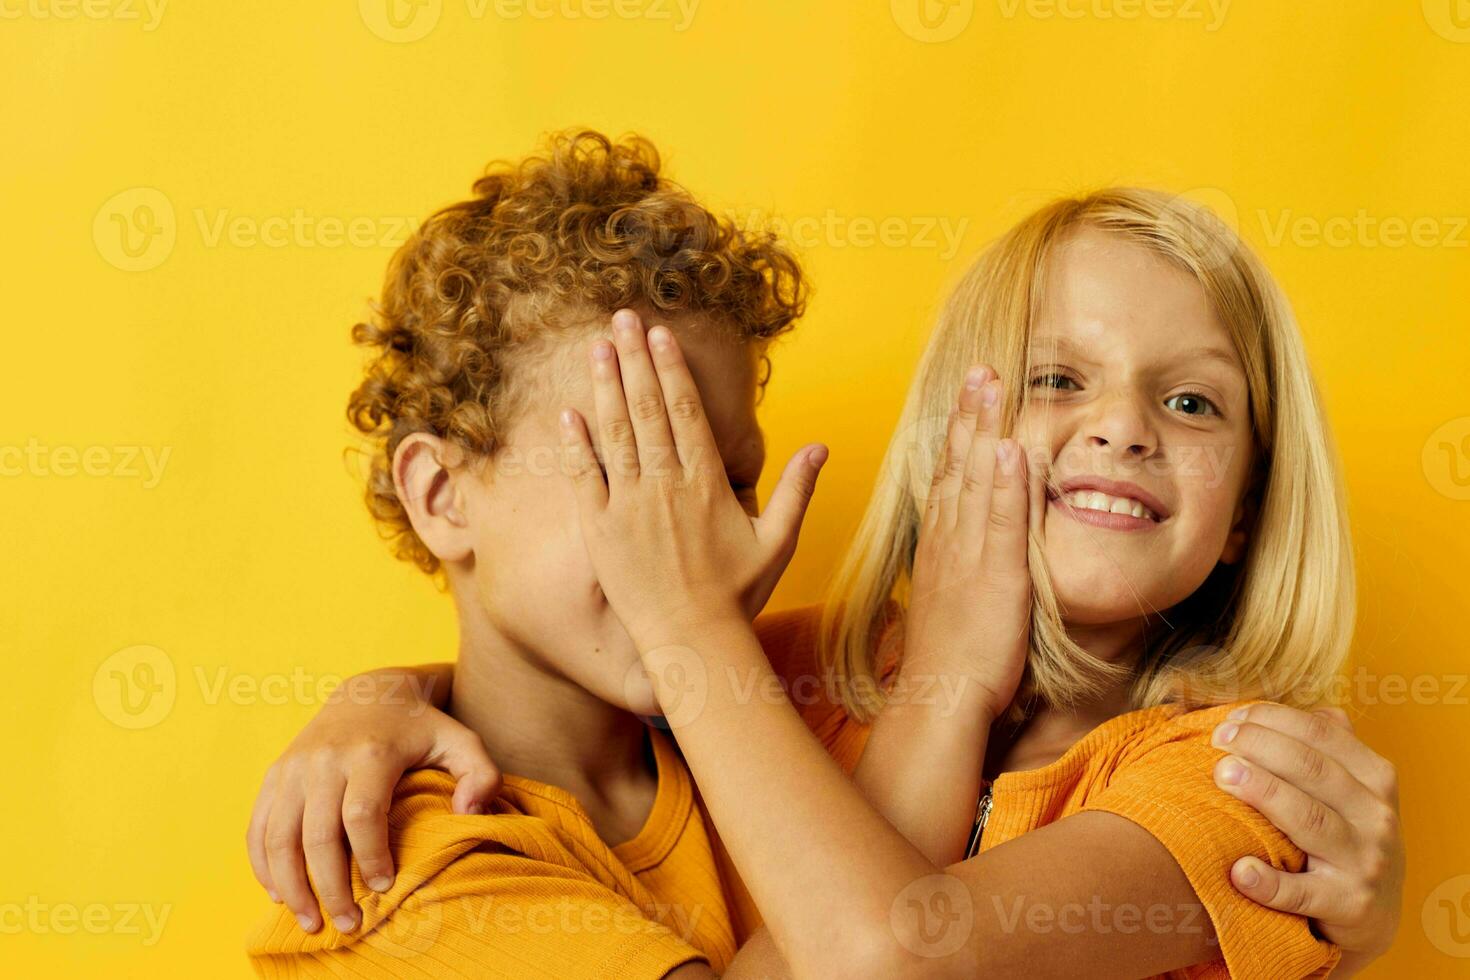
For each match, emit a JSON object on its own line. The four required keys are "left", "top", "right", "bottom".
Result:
{"left": 853, "top": 367, "right": 1045, "bottom": 864}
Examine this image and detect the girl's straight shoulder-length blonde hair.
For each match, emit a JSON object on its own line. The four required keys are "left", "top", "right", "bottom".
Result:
{"left": 820, "top": 188, "right": 1354, "bottom": 721}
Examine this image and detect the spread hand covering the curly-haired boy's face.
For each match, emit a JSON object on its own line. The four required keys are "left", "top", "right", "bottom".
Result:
{"left": 562, "top": 310, "right": 826, "bottom": 652}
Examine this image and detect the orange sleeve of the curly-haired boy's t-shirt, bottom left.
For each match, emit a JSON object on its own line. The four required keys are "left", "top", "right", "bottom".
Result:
{"left": 248, "top": 846, "right": 707, "bottom": 980}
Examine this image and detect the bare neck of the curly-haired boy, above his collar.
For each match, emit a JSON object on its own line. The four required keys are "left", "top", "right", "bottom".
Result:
{"left": 448, "top": 578, "right": 650, "bottom": 805}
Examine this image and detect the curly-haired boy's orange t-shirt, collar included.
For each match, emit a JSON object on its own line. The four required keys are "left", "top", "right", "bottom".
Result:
{"left": 247, "top": 732, "right": 736, "bottom": 980}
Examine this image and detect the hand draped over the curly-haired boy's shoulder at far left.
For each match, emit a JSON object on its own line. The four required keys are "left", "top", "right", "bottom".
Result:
{"left": 245, "top": 666, "right": 500, "bottom": 933}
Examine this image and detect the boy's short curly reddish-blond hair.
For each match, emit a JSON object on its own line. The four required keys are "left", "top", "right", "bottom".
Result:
{"left": 347, "top": 131, "right": 807, "bottom": 573}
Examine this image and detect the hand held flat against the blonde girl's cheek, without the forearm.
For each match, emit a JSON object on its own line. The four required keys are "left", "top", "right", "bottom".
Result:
{"left": 904, "top": 366, "right": 1045, "bottom": 718}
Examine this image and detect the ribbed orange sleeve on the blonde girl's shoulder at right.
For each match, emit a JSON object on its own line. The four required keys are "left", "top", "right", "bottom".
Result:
{"left": 1083, "top": 705, "right": 1339, "bottom": 977}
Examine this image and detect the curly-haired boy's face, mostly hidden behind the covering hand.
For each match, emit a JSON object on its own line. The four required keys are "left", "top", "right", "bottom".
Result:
{"left": 467, "top": 317, "right": 766, "bottom": 714}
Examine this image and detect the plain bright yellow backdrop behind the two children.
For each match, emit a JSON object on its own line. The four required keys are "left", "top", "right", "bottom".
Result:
{"left": 0, "top": 0, "right": 1470, "bottom": 977}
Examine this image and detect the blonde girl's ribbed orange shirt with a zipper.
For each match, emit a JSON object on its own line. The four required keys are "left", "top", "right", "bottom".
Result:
{"left": 742, "top": 608, "right": 1339, "bottom": 980}
